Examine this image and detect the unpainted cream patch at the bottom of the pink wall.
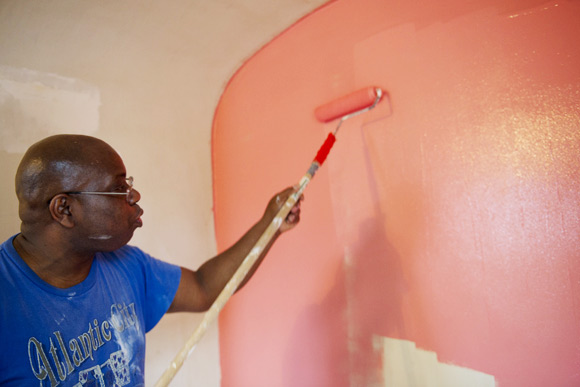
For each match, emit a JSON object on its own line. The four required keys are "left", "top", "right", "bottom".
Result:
{"left": 373, "top": 336, "right": 496, "bottom": 387}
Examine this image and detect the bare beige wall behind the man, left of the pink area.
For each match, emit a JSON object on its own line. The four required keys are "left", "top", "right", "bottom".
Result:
{"left": 0, "top": 0, "right": 325, "bottom": 386}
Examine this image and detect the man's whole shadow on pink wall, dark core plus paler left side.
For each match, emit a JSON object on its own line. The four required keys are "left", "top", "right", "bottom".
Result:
{"left": 284, "top": 216, "right": 407, "bottom": 387}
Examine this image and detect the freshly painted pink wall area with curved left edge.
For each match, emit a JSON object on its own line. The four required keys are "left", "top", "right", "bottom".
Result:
{"left": 212, "top": 0, "right": 580, "bottom": 387}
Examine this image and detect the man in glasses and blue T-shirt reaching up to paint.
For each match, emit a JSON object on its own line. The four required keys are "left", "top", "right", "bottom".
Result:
{"left": 0, "top": 135, "right": 300, "bottom": 387}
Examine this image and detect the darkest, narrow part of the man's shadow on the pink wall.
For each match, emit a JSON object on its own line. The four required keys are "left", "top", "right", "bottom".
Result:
{"left": 345, "top": 216, "right": 407, "bottom": 386}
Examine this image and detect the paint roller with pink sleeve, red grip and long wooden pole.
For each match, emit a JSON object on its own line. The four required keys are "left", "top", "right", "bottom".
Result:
{"left": 155, "top": 87, "right": 383, "bottom": 387}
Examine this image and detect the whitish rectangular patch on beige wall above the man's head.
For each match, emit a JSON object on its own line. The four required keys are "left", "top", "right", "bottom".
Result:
{"left": 0, "top": 66, "right": 101, "bottom": 153}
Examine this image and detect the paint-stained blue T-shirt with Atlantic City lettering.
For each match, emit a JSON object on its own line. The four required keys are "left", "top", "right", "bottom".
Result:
{"left": 0, "top": 237, "right": 181, "bottom": 387}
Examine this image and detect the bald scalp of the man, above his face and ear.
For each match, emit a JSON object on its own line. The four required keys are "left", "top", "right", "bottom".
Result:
{"left": 15, "top": 135, "right": 120, "bottom": 222}
